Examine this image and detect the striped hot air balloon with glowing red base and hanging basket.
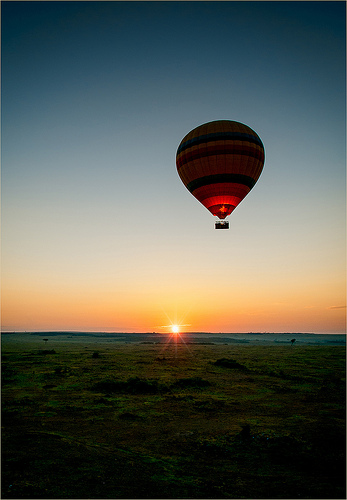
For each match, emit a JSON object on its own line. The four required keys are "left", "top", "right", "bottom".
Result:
{"left": 176, "top": 120, "right": 265, "bottom": 229}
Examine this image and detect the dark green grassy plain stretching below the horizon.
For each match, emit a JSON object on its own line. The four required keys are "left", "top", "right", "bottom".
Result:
{"left": 2, "top": 342, "right": 346, "bottom": 499}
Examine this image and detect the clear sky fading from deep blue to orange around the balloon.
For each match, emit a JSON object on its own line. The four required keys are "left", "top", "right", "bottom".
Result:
{"left": 1, "top": 1, "right": 346, "bottom": 333}
